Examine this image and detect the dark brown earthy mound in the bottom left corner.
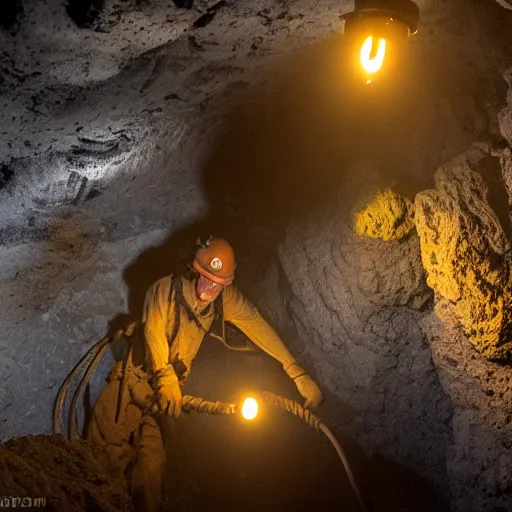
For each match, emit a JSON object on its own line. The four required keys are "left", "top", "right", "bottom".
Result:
{"left": 0, "top": 436, "right": 133, "bottom": 512}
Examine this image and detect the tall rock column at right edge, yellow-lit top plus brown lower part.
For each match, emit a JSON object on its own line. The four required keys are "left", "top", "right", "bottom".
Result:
{"left": 415, "top": 144, "right": 512, "bottom": 512}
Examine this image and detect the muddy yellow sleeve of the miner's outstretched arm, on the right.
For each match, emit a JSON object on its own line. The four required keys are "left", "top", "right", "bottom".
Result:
{"left": 223, "top": 285, "right": 295, "bottom": 367}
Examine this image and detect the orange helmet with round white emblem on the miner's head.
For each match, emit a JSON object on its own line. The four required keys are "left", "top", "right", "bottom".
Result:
{"left": 192, "top": 237, "right": 236, "bottom": 285}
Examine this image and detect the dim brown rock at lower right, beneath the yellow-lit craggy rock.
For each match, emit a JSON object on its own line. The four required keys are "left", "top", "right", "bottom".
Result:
{"left": 422, "top": 314, "right": 512, "bottom": 512}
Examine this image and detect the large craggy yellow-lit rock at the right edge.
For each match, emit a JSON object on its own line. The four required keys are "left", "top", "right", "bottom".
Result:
{"left": 415, "top": 145, "right": 512, "bottom": 359}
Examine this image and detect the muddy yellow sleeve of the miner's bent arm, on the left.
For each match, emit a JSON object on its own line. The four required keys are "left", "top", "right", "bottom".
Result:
{"left": 142, "top": 276, "right": 171, "bottom": 371}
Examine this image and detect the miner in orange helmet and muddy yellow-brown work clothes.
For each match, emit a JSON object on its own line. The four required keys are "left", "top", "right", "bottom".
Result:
{"left": 87, "top": 237, "right": 322, "bottom": 511}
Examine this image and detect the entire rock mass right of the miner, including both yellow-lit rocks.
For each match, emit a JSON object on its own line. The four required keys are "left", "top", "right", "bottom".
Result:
{"left": 280, "top": 143, "right": 512, "bottom": 512}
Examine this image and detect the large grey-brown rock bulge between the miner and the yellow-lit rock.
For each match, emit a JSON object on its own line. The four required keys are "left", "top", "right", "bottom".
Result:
{"left": 279, "top": 181, "right": 451, "bottom": 504}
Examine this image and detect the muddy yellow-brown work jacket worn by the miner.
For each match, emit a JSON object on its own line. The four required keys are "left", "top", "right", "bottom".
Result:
{"left": 143, "top": 275, "right": 295, "bottom": 380}
